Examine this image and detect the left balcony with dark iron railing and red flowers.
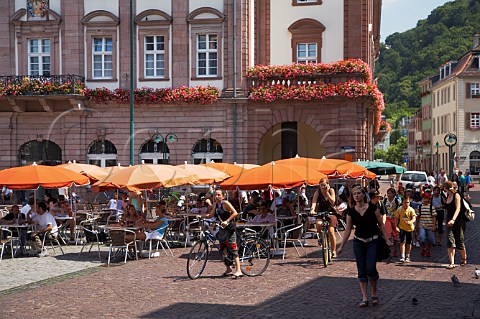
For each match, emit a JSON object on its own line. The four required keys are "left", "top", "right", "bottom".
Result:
{"left": 0, "top": 74, "right": 85, "bottom": 112}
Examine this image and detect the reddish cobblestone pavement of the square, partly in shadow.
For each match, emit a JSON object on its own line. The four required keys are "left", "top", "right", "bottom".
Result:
{"left": 0, "top": 186, "right": 480, "bottom": 319}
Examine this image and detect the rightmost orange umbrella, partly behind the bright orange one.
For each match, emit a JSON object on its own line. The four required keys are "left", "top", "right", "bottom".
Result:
{"left": 277, "top": 157, "right": 376, "bottom": 178}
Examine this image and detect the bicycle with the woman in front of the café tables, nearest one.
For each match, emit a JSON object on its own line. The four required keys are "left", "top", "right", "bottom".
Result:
{"left": 187, "top": 221, "right": 270, "bottom": 279}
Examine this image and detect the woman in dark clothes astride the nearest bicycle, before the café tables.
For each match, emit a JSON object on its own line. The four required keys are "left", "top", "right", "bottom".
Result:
{"left": 200, "top": 189, "right": 243, "bottom": 279}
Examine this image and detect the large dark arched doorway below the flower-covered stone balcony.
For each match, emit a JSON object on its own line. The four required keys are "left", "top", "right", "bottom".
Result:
{"left": 258, "top": 122, "right": 325, "bottom": 164}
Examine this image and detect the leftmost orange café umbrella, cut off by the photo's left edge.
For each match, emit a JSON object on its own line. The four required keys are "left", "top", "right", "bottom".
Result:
{"left": 0, "top": 163, "right": 89, "bottom": 189}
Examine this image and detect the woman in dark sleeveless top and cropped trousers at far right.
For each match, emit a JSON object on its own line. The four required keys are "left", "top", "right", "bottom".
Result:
{"left": 443, "top": 181, "right": 467, "bottom": 269}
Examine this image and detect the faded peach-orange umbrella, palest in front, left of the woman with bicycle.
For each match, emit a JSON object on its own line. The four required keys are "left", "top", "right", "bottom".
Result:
{"left": 92, "top": 164, "right": 198, "bottom": 191}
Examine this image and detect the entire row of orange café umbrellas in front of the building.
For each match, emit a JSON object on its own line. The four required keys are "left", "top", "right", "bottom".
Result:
{"left": 0, "top": 157, "right": 375, "bottom": 191}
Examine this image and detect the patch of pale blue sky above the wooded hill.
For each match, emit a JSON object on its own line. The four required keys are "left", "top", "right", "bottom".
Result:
{"left": 380, "top": 0, "right": 452, "bottom": 42}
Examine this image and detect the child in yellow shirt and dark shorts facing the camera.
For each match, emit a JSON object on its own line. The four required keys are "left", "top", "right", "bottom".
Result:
{"left": 395, "top": 197, "right": 416, "bottom": 263}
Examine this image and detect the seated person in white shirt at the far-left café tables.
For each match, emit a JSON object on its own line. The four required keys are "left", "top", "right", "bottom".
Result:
{"left": 27, "top": 202, "right": 58, "bottom": 257}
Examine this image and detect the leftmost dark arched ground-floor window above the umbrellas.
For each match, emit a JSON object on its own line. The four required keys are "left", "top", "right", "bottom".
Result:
{"left": 19, "top": 140, "right": 62, "bottom": 166}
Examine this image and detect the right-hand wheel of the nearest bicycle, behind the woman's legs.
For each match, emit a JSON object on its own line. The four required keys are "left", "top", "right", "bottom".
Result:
{"left": 238, "top": 236, "right": 270, "bottom": 277}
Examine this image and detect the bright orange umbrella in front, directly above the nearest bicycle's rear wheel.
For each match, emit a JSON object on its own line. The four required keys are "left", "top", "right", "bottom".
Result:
{"left": 220, "top": 162, "right": 326, "bottom": 189}
